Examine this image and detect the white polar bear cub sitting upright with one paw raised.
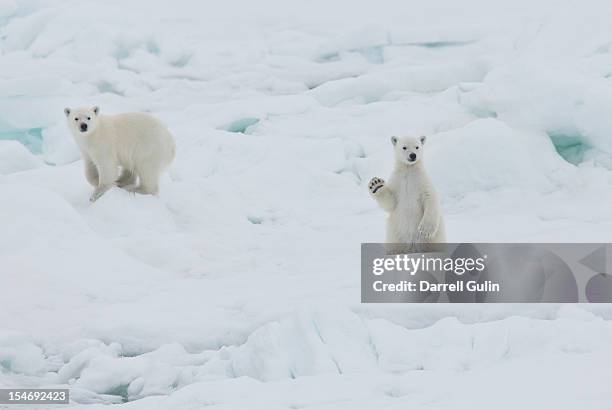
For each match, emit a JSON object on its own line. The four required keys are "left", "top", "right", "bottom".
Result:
{"left": 369, "top": 137, "right": 446, "bottom": 245}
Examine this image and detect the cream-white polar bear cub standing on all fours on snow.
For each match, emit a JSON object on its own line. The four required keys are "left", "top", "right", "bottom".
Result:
{"left": 64, "top": 107, "right": 176, "bottom": 202}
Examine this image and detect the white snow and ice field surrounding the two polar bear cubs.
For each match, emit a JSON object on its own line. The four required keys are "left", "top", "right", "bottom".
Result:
{"left": 0, "top": 0, "right": 612, "bottom": 410}
